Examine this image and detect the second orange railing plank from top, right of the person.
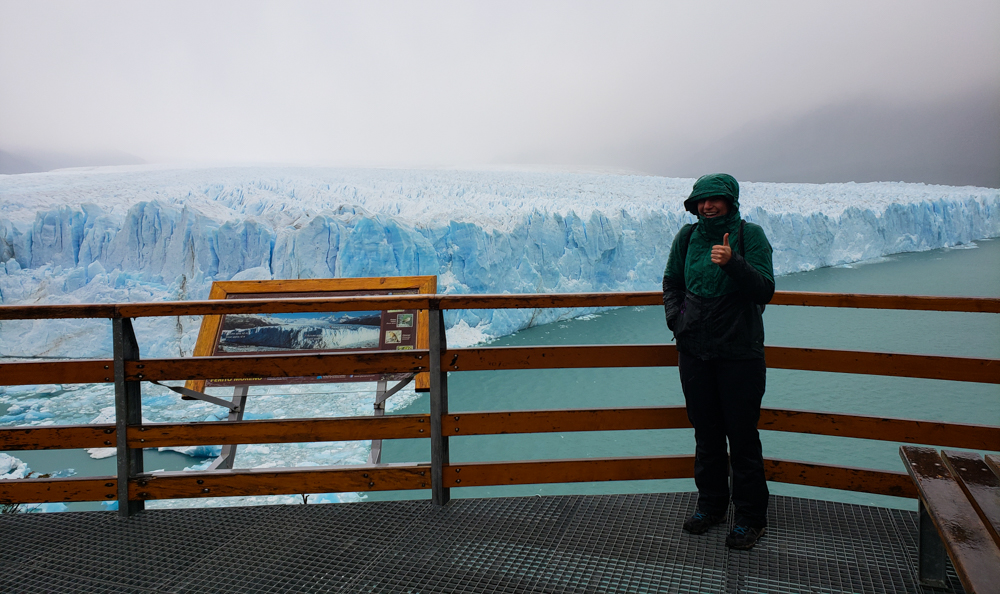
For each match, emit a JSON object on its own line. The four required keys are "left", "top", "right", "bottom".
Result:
{"left": 765, "top": 346, "right": 1000, "bottom": 384}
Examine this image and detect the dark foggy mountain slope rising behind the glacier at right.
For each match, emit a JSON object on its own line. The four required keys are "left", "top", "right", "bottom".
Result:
{"left": 645, "top": 90, "right": 1000, "bottom": 188}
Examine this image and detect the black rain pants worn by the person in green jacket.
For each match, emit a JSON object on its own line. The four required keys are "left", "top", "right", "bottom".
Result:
{"left": 678, "top": 353, "right": 768, "bottom": 528}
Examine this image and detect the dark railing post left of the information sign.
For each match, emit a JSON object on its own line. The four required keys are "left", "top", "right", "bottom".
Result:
{"left": 111, "top": 316, "right": 145, "bottom": 518}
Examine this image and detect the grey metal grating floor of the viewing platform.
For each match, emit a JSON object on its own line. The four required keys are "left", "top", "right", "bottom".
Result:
{"left": 0, "top": 493, "right": 962, "bottom": 594}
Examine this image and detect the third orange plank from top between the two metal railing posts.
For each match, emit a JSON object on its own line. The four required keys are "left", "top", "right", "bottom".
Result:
{"left": 128, "top": 415, "right": 431, "bottom": 448}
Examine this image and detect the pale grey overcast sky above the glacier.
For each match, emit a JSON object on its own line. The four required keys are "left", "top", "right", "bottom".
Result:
{"left": 0, "top": 0, "right": 1000, "bottom": 183}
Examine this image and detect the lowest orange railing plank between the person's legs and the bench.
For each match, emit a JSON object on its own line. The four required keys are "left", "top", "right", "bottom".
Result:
{"left": 764, "top": 458, "right": 917, "bottom": 498}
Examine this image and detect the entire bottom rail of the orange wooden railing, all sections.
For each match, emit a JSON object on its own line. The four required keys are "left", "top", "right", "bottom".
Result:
{"left": 0, "top": 456, "right": 916, "bottom": 503}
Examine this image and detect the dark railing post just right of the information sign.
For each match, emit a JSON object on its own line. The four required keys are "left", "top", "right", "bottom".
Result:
{"left": 427, "top": 303, "right": 451, "bottom": 505}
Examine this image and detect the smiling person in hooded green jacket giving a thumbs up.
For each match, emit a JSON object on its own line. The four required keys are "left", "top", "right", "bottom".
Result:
{"left": 663, "top": 173, "right": 774, "bottom": 549}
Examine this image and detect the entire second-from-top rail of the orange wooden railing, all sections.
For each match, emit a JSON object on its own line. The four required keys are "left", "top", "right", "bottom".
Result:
{"left": 0, "top": 345, "right": 1000, "bottom": 385}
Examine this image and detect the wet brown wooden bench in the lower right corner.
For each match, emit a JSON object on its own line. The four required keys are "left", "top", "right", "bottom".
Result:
{"left": 899, "top": 446, "right": 1000, "bottom": 594}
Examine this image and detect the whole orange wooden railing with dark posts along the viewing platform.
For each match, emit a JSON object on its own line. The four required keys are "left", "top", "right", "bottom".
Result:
{"left": 0, "top": 292, "right": 1000, "bottom": 515}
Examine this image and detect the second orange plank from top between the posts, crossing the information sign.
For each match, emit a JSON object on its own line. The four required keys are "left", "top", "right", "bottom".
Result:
{"left": 125, "top": 350, "right": 430, "bottom": 381}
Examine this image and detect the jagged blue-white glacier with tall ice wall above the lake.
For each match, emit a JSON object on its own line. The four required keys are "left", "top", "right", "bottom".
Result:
{"left": 0, "top": 167, "right": 1000, "bottom": 357}
